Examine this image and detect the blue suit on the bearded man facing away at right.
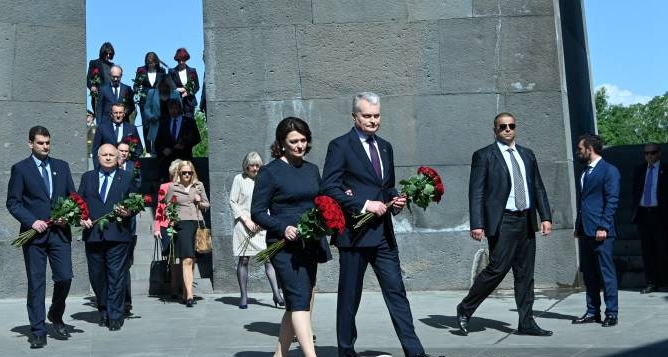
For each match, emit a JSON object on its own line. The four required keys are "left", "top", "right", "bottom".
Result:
{"left": 575, "top": 159, "right": 620, "bottom": 317}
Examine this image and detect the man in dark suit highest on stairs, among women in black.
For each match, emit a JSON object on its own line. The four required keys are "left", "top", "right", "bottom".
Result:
{"left": 95, "top": 65, "right": 135, "bottom": 125}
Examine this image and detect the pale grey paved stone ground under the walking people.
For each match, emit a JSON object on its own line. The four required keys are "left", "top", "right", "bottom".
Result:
{"left": 0, "top": 291, "right": 668, "bottom": 357}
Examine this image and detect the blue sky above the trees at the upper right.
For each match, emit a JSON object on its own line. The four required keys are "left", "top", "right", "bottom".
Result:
{"left": 584, "top": 0, "right": 668, "bottom": 105}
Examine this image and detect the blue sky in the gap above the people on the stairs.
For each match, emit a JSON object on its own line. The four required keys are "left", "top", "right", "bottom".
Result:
{"left": 87, "top": 0, "right": 204, "bottom": 117}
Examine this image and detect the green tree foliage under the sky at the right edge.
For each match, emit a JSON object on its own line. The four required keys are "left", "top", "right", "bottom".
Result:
{"left": 594, "top": 88, "right": 668, "bottom": 145}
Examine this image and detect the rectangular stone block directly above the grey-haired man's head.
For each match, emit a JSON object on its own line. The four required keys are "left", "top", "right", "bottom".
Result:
{"left": 297, "top": 22, "right": 441, "bottom": 98}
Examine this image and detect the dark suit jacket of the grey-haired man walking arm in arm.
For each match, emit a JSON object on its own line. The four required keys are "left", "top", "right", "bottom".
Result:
{"left": 321, "top": 129, "right": 398, "bottom": 247}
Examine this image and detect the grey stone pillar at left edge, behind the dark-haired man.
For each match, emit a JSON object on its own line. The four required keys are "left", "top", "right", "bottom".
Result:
{"left": 0, "top": 0, "right": 88, "bottom": 297}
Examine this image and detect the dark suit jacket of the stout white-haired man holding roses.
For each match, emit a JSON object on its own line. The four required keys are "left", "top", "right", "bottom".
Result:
{"left": 79, "top": 169, "right": 139, "bottom": 243}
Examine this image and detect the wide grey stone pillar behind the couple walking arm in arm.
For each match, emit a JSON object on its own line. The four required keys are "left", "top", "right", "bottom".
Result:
{"left": 204, "top": 0, "right": 593, "bottom": 291}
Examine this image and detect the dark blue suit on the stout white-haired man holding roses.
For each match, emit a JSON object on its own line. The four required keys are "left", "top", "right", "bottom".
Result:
{"left": 79, "top": 170, "right": 138, "bottom": 320}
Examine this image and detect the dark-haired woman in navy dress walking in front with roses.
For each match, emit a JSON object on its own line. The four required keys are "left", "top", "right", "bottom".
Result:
{"left": 251, "top": 117, "right": 331, "bottom": 357}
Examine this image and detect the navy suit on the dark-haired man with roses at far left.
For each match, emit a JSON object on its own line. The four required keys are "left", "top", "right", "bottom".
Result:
{"left": 7, "top": 156, "right": 74, "bottom": 336}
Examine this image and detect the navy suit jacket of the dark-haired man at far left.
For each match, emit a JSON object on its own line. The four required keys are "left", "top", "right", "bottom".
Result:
{"left": 7, "top": 156, "right": 75, "bottom": 244}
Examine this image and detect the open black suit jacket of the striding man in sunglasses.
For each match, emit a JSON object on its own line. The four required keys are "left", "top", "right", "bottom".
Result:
{"left": 469, "top": 142, "right": 552, "bottom": 237}
